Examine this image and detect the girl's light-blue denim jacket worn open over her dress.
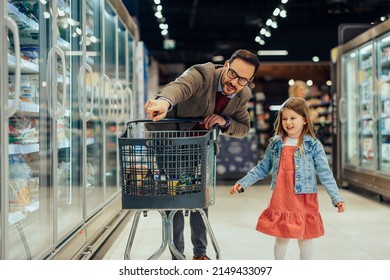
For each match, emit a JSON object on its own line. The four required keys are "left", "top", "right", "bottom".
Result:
{"left": 237, "top": 135, "right": 343, "bottom": 205}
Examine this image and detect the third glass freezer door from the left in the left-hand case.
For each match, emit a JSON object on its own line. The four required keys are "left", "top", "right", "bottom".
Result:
{"left": 84, "top": 0, "right": 104, "bottom": 218}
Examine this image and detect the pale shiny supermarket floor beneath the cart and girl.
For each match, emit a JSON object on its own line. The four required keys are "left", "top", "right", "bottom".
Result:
{"left": 94, "top": 185, "right": 390, "bottom": 260}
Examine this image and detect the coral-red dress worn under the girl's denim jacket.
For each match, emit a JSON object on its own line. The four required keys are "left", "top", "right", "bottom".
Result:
{"left": 256, "top": 146, "right": 324, "bottom": 239}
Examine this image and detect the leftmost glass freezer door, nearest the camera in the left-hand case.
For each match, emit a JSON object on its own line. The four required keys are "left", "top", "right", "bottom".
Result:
{"left": 5, "top": 0, "right": 53, "bottom": 260}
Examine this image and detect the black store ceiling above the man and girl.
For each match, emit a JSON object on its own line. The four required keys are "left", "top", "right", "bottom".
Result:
{"left": 123, "top": 0, "right": 390, "bottom": 81}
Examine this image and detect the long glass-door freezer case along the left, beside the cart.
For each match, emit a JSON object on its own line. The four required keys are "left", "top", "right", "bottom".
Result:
{"left": 0, "top": 0, "right": 138, "bottom": 260}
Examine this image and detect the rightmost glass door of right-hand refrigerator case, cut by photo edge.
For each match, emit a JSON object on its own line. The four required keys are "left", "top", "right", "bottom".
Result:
{"left": 377, "top": 34, "right": 390, "bottom": 174}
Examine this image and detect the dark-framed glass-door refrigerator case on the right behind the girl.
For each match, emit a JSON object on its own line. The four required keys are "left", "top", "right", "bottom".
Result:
{"left": 332, "top": 20, "right": 390, "bottom": 200}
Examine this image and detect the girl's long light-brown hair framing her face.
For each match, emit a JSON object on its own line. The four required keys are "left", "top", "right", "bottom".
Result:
{"left": 274, "top": 97, "right": 317, "bottom": 151}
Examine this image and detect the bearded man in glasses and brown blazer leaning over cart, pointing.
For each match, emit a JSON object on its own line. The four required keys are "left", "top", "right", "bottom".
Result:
{"left": 145, "top": 49, "right": 260, "bottom": 260}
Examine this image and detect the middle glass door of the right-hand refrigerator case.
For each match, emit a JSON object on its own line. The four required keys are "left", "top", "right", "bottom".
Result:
{"left": 358, "top": 43, "right": 376, "bottom": 170}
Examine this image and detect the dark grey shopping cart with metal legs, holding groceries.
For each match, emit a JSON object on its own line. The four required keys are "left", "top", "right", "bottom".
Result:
{"left": 118, "top": 119, "right": 220, "bottom": 260}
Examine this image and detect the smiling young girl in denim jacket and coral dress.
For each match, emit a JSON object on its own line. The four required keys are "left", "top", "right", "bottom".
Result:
{"left": 230, "top": 97, "right": 344, "bottom": 260}
